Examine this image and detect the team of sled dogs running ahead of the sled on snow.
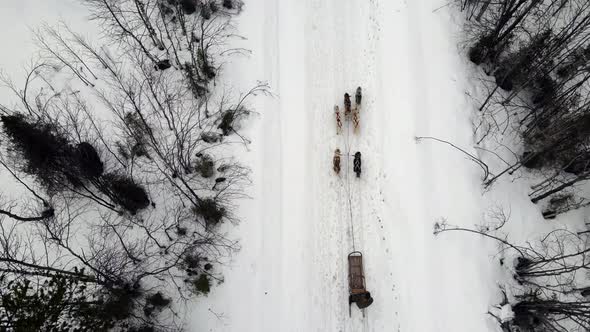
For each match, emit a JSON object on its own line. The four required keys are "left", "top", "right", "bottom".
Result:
{"left": 332, "top": 86, "right": 363, "bottom": 178}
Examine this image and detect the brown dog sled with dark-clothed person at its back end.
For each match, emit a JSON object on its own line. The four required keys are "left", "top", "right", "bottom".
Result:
{"left": 348, "top": 251, "right": 373, "bottom": 316}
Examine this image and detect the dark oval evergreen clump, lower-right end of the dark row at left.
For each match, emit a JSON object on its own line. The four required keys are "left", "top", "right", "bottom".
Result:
{"left": 103, "top": 173, "right": 150, "bottom": 214}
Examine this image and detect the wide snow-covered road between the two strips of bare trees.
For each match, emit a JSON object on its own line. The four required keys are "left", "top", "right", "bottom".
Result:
{"left": 193, "top": 0, "right": 504, "bottom": 332}
